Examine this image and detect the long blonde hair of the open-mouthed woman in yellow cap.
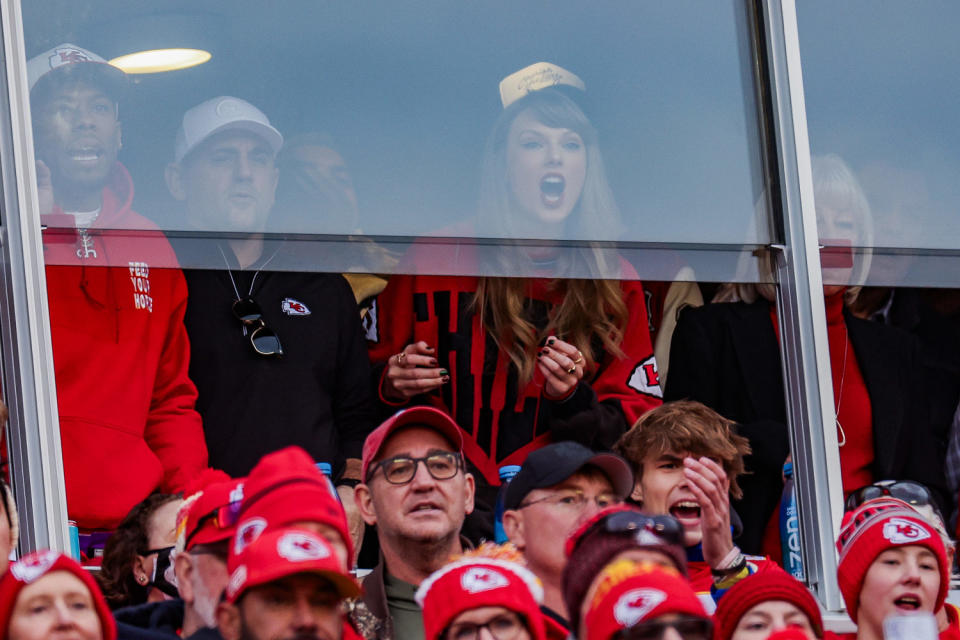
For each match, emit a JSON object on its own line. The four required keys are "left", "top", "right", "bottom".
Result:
{"left": 473, "top": 88, "right": 627, "bottom": 387}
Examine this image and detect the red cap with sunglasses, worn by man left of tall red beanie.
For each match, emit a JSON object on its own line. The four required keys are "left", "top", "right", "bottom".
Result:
{"left": 177, "top": 470, "right": 243, "bottom": 551}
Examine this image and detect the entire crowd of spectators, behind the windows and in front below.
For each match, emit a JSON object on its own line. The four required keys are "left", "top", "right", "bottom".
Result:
{"left": 0, "top": 44, "right": 960, "bottom": 640}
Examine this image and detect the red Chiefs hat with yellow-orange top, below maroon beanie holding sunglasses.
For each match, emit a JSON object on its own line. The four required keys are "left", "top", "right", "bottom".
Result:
{"left": 574, "top": 560, "right": 708, "bottom": 640}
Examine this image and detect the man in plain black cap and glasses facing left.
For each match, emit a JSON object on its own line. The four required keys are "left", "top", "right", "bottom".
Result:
{"left": 503, "top": 442, "right": 633, "bottom": 638}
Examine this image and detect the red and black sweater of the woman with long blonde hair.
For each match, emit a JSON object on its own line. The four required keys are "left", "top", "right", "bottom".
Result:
{"left": 368, "top": 248, "right": 662, "bottom": 485}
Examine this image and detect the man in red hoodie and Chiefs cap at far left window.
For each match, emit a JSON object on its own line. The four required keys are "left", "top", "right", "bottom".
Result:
{"left": 27, "top": 44, "right": 207, "bottom": 530}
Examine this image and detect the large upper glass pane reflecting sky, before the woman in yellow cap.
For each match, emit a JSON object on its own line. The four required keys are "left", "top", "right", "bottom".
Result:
{"left": 23, "top": 0, "right": 771, "bottom": 281}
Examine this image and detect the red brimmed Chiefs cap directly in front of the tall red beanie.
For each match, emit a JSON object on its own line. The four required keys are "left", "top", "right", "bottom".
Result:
{"left": 226, "top": 528, "right": 360, "bottom": 602}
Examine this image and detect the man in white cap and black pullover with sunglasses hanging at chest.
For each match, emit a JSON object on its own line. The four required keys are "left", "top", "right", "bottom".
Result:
{"left": 166, "top": 96, "right": 374, "bottom": 542}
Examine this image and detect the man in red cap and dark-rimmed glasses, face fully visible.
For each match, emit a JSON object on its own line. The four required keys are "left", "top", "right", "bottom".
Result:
{"left": 353, "top": 407, "right": 474, "bottom": 640}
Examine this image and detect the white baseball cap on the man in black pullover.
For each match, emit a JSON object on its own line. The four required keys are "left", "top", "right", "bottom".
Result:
{"left": 173, "top": 96, "right": 283, "bottom": 162}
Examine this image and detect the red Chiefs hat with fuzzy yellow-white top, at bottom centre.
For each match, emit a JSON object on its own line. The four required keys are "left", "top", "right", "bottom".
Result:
{"left": 416, "top": 557, "right": 546, "bottom": 640}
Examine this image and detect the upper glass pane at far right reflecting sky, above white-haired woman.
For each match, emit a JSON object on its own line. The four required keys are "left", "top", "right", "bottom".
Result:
{"left": 797, "top": 0, "right": 960, "bottom": 287}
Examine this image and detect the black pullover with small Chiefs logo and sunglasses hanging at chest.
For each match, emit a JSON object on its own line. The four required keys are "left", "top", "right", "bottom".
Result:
{"left": 184, "top": 258, "right": 375, "bottom": 477}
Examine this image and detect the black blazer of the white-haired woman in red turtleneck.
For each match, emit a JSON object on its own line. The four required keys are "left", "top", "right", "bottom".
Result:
{"left": 664, "top": 300, "right": 946, "bottom": 553}
